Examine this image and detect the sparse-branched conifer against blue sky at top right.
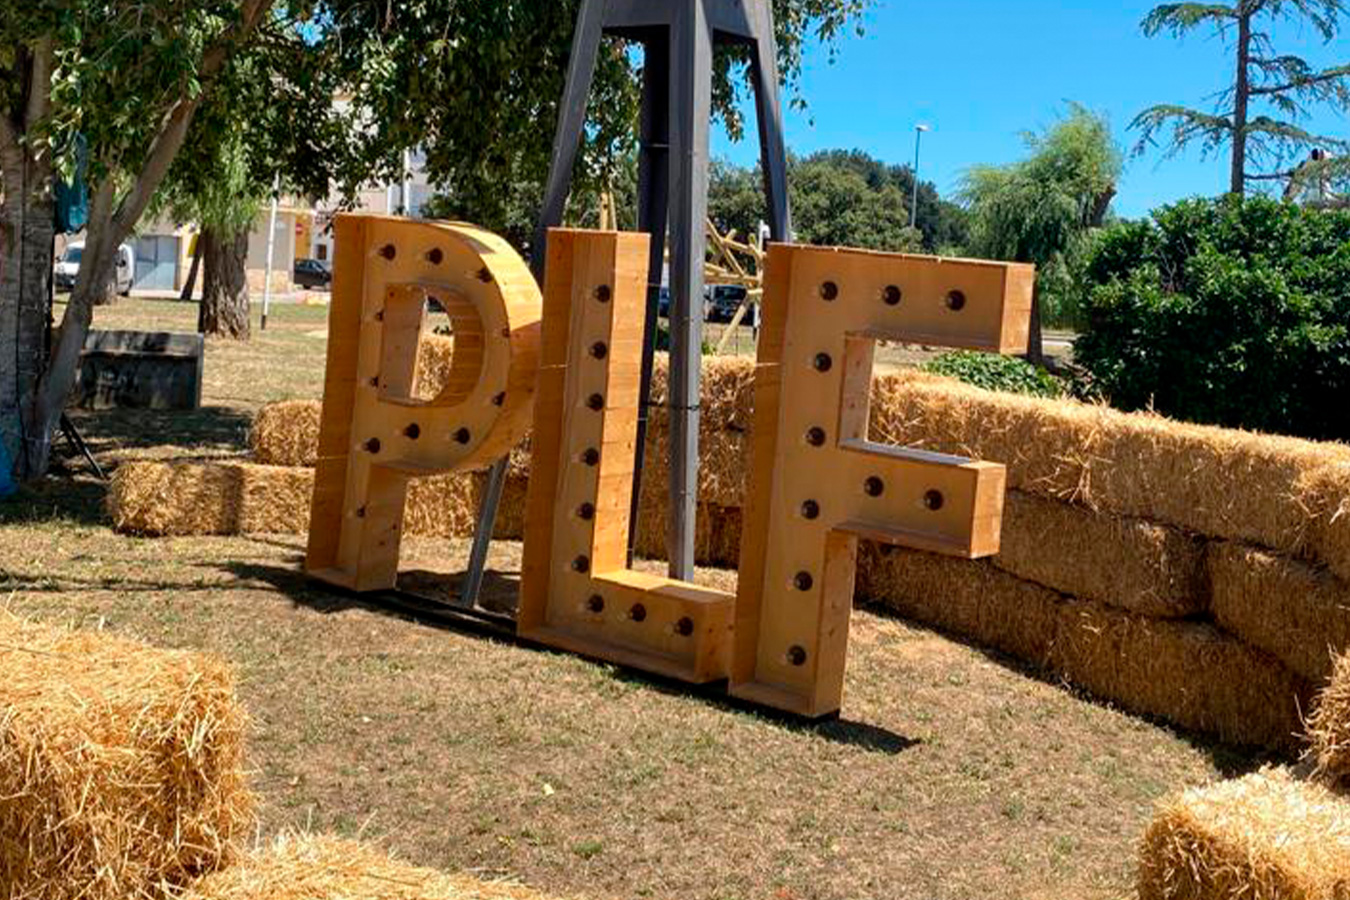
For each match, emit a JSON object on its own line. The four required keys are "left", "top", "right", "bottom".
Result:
{"left": 1131, "top": 0, "right": 1350, "bottom": 194}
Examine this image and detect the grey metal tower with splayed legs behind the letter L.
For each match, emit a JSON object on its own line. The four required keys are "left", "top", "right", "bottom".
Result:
{"left": 460, "top": 0, "right": 791, "bottom": 606}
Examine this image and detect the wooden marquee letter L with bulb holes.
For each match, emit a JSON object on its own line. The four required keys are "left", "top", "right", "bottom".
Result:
{"left": 518, "top": 229, "right": 734, "bottom": 683}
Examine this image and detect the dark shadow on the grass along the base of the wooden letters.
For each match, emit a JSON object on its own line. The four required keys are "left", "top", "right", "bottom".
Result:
{"left": 211, "top": 561, "right": 921, "bottom": 756}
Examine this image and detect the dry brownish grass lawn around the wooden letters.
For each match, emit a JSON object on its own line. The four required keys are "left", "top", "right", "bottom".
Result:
{"left": 0, "top": 300, "right": 1257, "bottom": 900}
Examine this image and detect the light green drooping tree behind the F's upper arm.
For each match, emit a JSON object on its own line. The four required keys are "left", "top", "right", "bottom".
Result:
{"left": 961, "top": 104, "right": 1122, "bottom": 341}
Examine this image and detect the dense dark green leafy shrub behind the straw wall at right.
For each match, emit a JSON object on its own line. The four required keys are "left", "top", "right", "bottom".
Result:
{"left": 1075, "top": 197, "right": 1350, "bottom": 440}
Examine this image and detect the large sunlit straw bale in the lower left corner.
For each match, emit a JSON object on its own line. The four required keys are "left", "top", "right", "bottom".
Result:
{"left": 0, "top": 614, "right": 254, "bottom": 900}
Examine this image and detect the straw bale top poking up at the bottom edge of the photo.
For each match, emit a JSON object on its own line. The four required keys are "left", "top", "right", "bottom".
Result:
{"left": 180, "top": 834, "right": 558, "bottom": 900}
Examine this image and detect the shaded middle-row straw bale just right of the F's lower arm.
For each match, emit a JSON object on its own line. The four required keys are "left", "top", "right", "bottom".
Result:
{"left": 991, "top": 491, "right": 1207, "bottom": 618}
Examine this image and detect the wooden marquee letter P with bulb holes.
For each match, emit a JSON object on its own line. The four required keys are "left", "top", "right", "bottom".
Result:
{"left": 305, "top": 216, "right": 541, "bottom": 591}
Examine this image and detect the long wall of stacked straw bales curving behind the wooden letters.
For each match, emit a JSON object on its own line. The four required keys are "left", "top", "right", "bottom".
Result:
{"left": 113, "top": 358, "right": 1350, "bottom": 745}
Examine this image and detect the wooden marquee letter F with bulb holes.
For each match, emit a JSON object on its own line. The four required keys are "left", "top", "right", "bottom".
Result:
{"left": 732, "top": 246, "right": 1034, "bottom": 716}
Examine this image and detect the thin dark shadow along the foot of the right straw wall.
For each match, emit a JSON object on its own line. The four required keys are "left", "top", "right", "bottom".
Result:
{"left": 856, "top": 600, "right": 1274, "bottom": 779}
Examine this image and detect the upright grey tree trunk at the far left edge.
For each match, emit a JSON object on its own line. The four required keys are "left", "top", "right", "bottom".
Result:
{"left": 0, "top": 147, "right": 55, "bottom": 482}
